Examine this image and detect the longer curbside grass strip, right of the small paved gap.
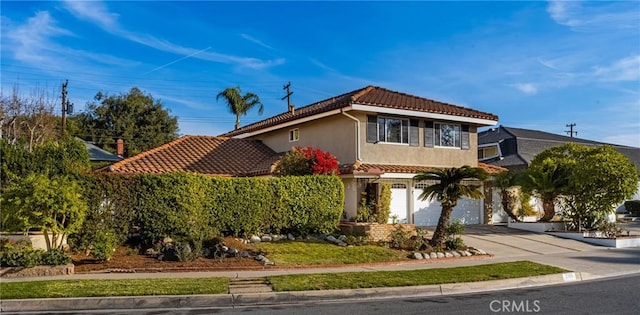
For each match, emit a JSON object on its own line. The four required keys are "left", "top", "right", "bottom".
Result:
{"left": 268, "top": 261, "right": 567, "bottom": 291}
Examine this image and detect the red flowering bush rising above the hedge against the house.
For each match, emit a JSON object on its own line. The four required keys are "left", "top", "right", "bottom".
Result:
{"left": 275, "top": 147, "right": 339, "bottom": 176}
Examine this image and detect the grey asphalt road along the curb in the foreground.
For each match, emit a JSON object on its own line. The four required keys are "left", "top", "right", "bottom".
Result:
{"left": 16, "top": 274, "right": 640, "bottom": 315}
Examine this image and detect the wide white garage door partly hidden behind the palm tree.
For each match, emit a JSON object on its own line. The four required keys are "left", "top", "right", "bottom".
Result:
{"left": 413, "top": 184, "right": 482, "bottom": 226}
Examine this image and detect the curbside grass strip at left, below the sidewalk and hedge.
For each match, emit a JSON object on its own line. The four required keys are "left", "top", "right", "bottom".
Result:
{"left": 0, "top": 278, "right": 229, "bottom": 299}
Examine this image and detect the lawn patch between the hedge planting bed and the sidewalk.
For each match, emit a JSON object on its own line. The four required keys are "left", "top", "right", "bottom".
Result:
{"left": 251, "top": 241, "right": 409, "bottom": 266}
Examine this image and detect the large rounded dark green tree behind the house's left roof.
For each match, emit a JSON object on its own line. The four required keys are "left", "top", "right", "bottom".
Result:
{"left": 70, "top": 87, "right": 178, "bottom": 157}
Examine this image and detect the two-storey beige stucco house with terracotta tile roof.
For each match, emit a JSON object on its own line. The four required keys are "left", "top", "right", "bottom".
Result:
{"left": 109, "top": 86, "right": 505, "bottom": 226}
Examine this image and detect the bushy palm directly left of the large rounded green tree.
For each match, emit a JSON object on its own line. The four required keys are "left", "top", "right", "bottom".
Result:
{"left": 524, "top": 159, "right": 569, "bottom": 222}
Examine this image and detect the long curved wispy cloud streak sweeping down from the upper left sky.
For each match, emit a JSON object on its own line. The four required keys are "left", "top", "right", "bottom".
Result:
{"left": 65, "top": 1, "right": 285, "bottom": 69}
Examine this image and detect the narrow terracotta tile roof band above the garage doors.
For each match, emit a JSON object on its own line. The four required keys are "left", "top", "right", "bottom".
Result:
{"left": 340, "top": 163, "right": 507, "bottom": 175}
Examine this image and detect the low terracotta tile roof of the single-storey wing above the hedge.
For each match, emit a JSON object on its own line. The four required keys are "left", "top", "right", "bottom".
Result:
{"left": 102, "top": 136, "right": 279, "bottom": 176}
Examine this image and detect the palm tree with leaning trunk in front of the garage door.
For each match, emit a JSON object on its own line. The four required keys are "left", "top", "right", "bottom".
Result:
{"left": 413, "top": 165, "right": 487, "bottom": 248}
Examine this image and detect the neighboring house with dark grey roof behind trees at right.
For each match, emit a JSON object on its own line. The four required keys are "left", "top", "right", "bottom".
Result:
{"left": 478, "top": 126, "right": 640, "bottom": 222}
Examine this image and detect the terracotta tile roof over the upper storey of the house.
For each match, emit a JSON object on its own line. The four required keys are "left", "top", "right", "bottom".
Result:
{"left": 223, "top": 86, "right": 498, "bottom": 137}
